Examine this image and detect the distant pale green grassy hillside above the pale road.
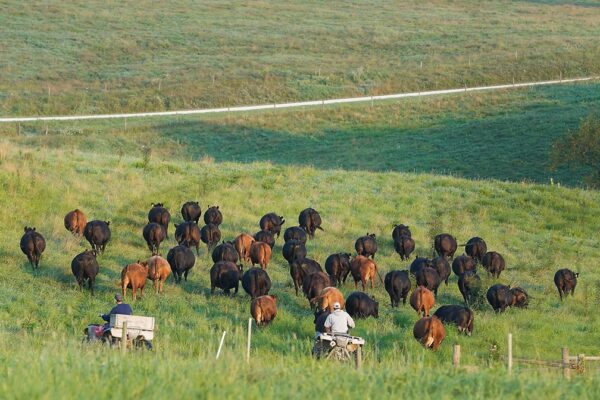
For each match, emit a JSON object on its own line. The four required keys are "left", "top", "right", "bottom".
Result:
{"left": 0, "top": 0, "right": 600, "bottom": 115}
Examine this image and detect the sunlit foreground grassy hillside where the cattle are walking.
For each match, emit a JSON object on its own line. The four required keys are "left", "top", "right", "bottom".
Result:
{"left": 0, "top": 141, "right": 600, "bottom": 398}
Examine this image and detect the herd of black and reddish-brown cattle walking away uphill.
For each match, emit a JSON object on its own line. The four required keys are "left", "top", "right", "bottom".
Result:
{"left": 20, "top": 201, "right": 578, "bottom": 349}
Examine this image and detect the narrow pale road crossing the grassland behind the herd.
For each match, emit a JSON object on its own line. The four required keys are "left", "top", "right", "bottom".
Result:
{"left": 0, "top": 76, "right": 600, "bottom": 123}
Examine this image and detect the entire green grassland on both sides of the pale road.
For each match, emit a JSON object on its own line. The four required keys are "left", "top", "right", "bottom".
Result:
{"left": 0, "top": 0, "right": 600, "bottom": 399}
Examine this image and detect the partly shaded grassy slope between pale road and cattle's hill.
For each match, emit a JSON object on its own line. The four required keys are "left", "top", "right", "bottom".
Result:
{"left": 5, "top": 83, "right": 600, "bottom": 186}
